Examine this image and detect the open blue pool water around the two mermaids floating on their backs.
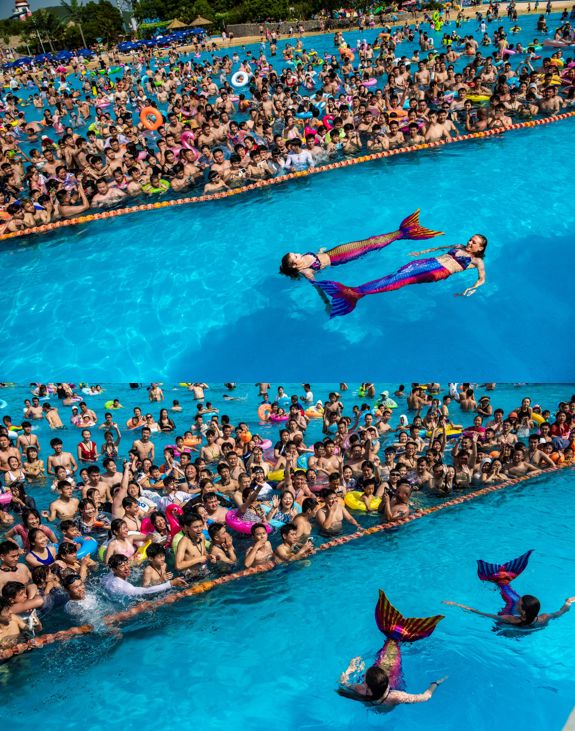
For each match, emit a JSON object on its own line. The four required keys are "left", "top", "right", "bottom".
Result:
{"left": 0, "top": 17, "right": 575, "bottom": 381}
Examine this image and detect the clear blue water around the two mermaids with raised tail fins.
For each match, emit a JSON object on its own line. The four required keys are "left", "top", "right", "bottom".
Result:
{"left": 2, "top": 448, "right": 575, "bottom": 731}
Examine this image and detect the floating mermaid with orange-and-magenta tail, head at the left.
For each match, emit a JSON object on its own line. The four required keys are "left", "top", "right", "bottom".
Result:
{"left": 280, "top": 209, "right": 442, "bottom": 282}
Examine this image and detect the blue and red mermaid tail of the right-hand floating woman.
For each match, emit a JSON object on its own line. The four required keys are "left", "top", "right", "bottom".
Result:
{"left": 313, "top": 258, "right": 451, "bottom": 318}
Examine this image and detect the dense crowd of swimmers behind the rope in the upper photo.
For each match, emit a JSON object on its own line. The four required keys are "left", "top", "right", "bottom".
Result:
{"left": 0, "top": 4, "right": 575, "bottom": 234}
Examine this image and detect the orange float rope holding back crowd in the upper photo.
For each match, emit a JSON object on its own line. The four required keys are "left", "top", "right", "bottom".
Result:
{"left": 0, "top": 112, "right": 575, "bottom": 241}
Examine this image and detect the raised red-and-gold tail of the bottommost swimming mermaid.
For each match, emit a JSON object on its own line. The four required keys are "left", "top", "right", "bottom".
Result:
{"left": 375, "top": 589, "right": 443, "bottom": 690}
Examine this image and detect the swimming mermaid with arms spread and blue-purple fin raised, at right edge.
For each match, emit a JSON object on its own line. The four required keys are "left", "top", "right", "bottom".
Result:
{"left": 444, "top": 550, "right": 575, "bottom": 628}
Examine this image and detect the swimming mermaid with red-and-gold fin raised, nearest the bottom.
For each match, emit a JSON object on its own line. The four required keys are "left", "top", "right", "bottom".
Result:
{"left": 338, "top": 591, "right": 446, "bottom": 706}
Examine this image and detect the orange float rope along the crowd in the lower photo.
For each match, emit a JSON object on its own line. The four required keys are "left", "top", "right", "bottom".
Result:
{"left": 0, "top": 465, "right": 571, "bottom": 660}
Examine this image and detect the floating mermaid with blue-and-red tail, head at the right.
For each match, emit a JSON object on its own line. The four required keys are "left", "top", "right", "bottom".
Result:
{"left": 314, "top": 234, "right": 487, "bottom": 317}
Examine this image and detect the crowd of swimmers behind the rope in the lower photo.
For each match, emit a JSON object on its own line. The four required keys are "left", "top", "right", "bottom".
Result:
{"left": 0, "top": 383, "right": 575, "bottom": 646}
